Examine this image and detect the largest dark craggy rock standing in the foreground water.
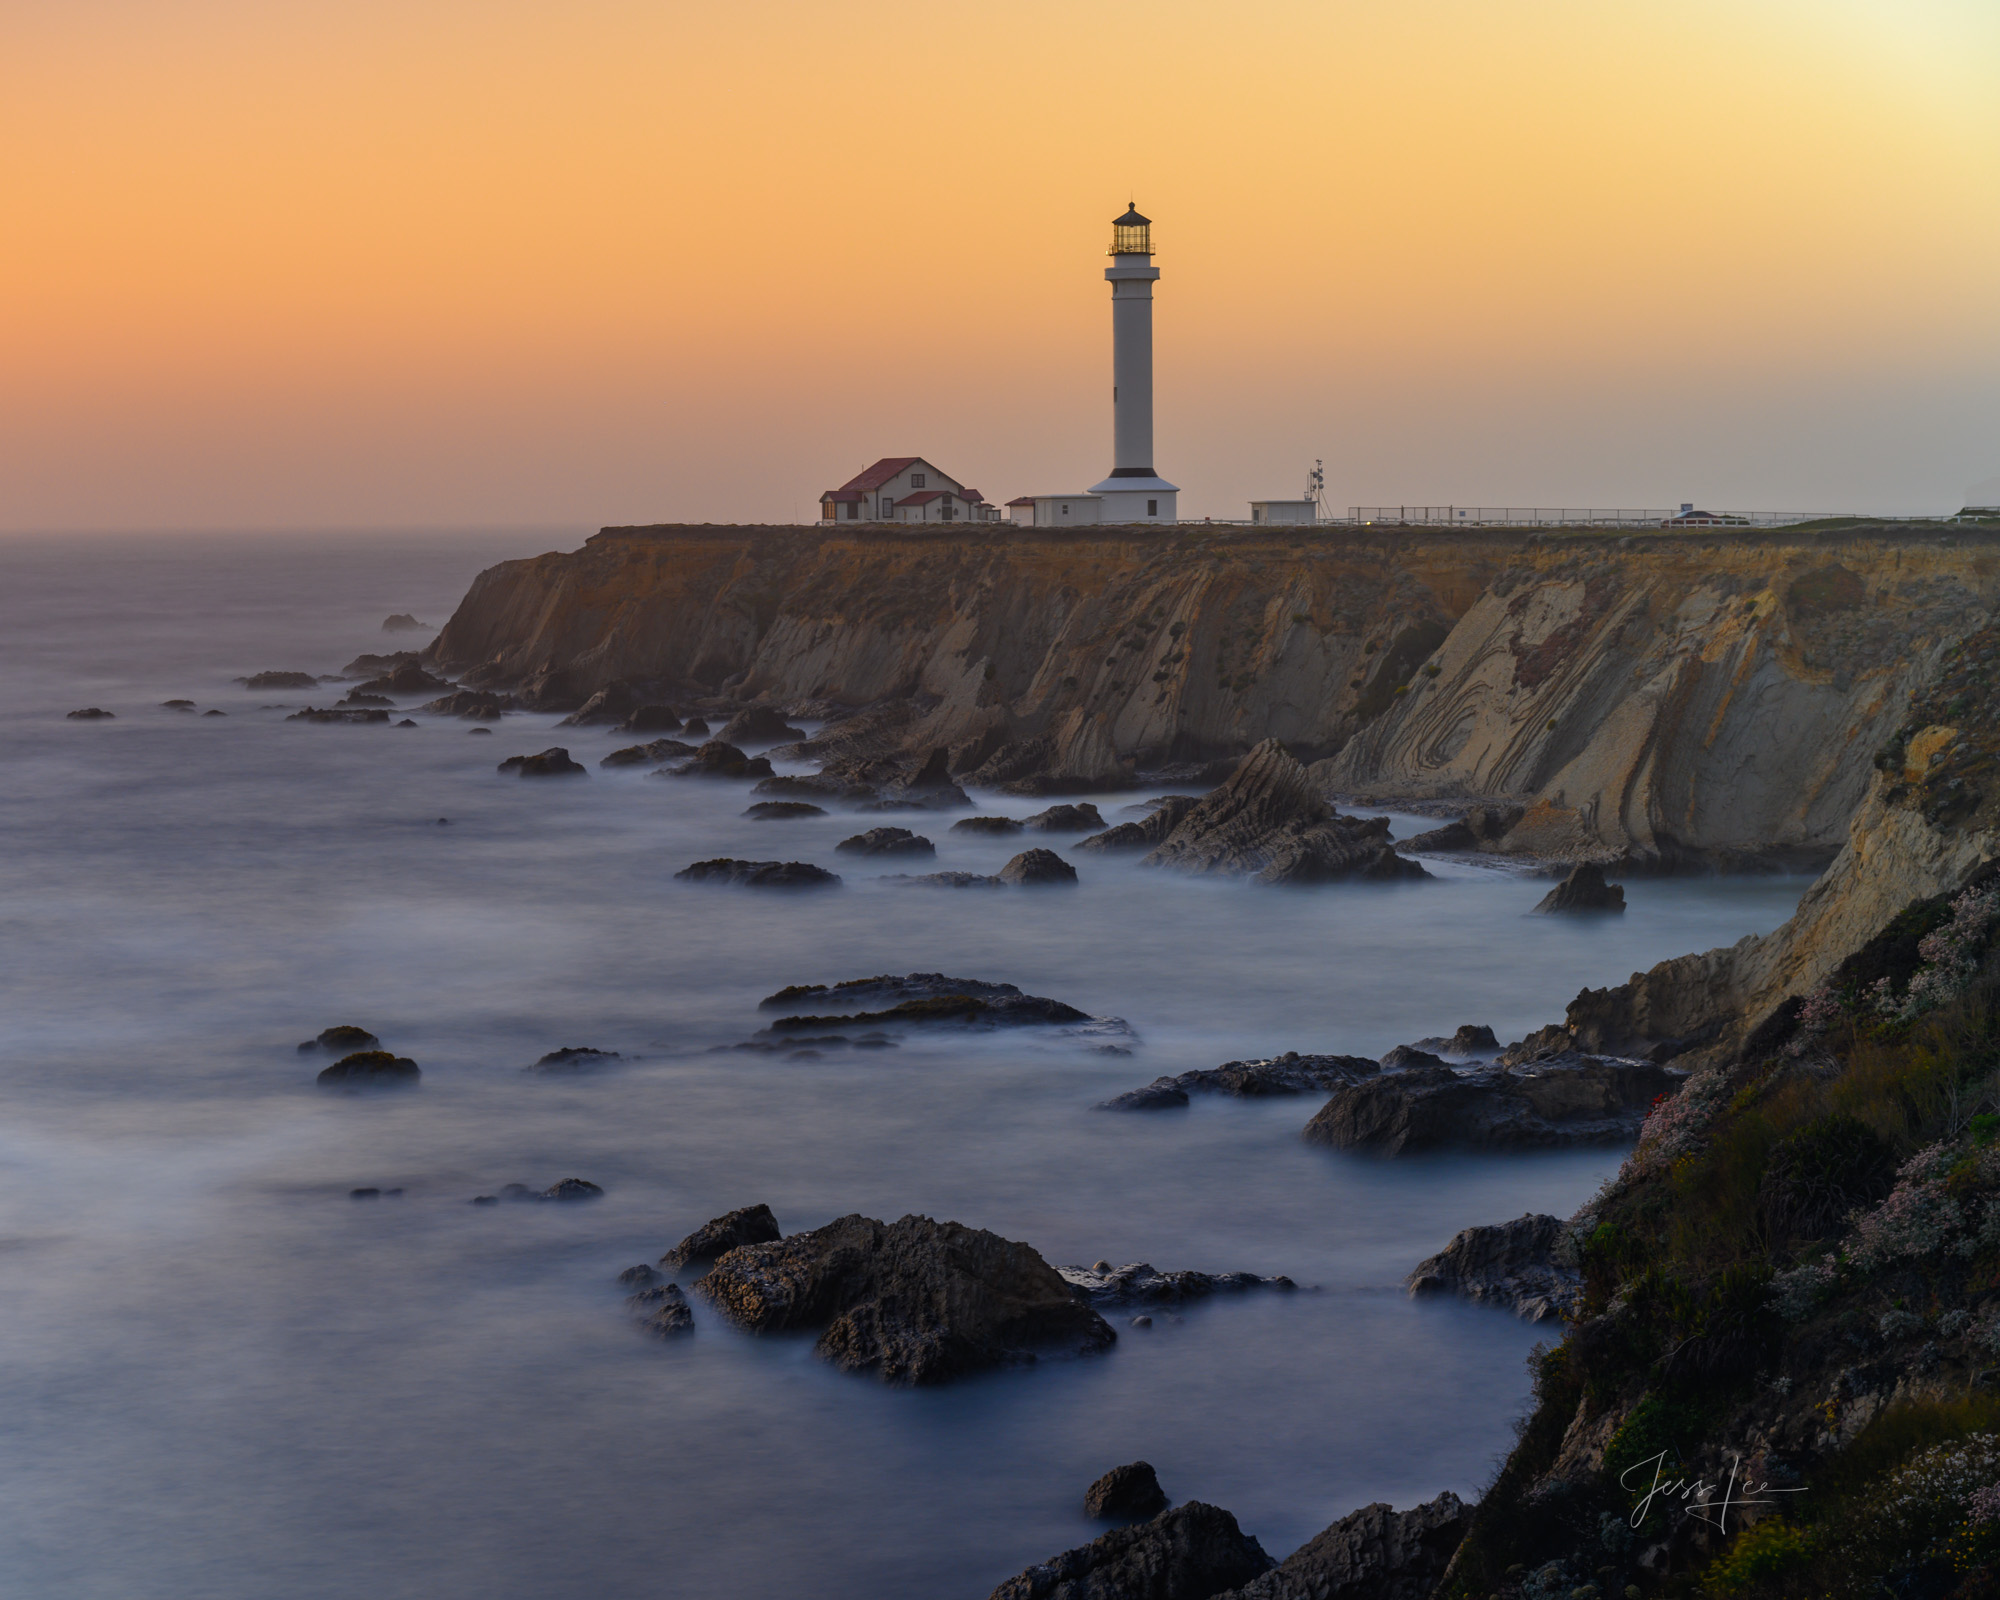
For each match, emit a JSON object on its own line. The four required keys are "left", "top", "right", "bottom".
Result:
{"left": 696, "top": 1216, "right": 1118, "bottom": 1384}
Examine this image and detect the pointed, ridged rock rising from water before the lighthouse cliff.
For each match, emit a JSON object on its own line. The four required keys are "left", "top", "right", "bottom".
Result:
{"left": 1146, "top": 738, "right": 1430, "bottom": 884}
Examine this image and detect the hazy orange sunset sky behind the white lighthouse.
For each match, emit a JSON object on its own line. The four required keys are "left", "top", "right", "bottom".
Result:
{"left": 0, "top": 0, "right": 2000, "bottom": 528}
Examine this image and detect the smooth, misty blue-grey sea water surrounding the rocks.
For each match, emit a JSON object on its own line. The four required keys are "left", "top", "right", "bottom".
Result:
{"left": 0, "top": 530, "right": 1804, "bottom": 1600}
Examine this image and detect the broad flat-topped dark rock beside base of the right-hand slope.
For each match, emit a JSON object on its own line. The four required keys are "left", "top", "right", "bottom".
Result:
{"left": 1306, "top": 1054, "right": 1686, "bottom": 1156}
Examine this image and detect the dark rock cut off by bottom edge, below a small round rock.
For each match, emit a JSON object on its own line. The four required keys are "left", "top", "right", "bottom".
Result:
{"left": 990, "top": 1500, "right": 1272, "bottom": 1600}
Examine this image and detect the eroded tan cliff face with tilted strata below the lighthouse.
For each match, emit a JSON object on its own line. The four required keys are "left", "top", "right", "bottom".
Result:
{"left": 432, "top": 526, "right": 2000, "bottom": 866}
